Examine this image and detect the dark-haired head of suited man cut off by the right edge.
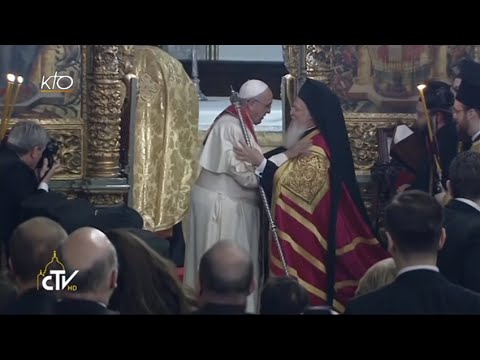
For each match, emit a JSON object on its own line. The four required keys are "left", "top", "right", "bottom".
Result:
{"left": 447, "top": 151, "right": 480, "bottom": 201}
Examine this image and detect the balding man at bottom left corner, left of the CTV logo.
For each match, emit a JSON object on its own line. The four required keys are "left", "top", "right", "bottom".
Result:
{"left": 4, "top": 217, "right": 67, "bottom": 315}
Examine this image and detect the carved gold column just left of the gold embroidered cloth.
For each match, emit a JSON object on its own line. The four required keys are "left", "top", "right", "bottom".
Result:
{"left": 87, "top": 45, "right": 125, "bottom": 178}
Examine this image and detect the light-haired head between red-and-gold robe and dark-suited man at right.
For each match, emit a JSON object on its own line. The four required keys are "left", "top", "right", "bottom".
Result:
{"left": 355, "top": 258, "right": 397, "bottom": 296}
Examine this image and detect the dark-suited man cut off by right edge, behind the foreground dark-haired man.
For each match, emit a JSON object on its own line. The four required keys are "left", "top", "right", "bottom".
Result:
{"left": 438, "top": 151, "right": 480, "bottom": 293}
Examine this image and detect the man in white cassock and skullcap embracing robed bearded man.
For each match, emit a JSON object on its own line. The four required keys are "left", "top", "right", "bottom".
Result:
{"left": 184, "top": 80, "right": 273, "bottom": 312}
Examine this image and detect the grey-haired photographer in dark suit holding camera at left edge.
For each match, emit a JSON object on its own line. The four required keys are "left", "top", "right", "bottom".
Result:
{"left": 0, "top": 121, "right": 60, "bottom": 258}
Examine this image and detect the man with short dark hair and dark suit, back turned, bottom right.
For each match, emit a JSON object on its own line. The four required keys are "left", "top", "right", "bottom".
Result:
{"left": 345, "top": 190, "right": 480, "bottom": 314}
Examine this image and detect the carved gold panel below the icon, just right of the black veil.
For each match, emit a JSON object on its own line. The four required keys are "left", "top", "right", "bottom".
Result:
{"left": 345, "top": 113, "right": 415, "bottom": 175}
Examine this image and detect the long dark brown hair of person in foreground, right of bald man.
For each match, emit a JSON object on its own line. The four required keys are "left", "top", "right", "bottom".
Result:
{"left": 107, "top": 229, "right": 191, "bottom": 314}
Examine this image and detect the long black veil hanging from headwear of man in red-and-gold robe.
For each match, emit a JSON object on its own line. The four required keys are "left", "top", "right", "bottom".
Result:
{"left": 298, "top": 79, "right": 372, "bottom": 306}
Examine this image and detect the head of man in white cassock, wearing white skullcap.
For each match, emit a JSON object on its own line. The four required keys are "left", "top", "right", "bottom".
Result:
{"left": 238, "top": 79, "right": 273, "bottom": 125}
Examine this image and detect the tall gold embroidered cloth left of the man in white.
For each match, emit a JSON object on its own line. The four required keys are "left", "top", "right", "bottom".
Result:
{"left": 133, "top": 46, "right": 199, "bottom": 231}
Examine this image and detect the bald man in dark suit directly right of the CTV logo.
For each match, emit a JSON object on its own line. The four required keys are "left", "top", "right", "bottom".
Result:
{"left": 55, "top": 227, "right": 118, "bottom": 315}
